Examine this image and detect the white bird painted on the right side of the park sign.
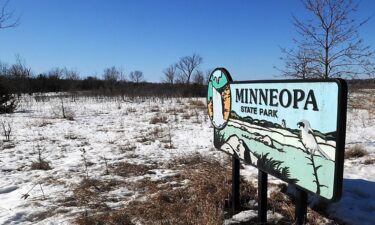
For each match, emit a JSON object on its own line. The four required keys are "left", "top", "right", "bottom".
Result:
{"left": 297, "top": 120, "right": 330, "bottom": 159}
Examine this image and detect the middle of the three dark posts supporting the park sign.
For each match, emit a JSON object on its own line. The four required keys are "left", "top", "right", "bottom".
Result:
{"left": 258, "top": 170, "right": 268, "bottom": 224}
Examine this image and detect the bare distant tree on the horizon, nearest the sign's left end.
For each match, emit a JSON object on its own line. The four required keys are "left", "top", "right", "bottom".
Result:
{"left": 176, "top": 54, "right": 203, "bottom": 84}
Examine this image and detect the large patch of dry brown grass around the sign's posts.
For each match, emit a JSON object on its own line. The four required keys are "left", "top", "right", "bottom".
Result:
{"left": 72, "top": 154, "right": 336, "bottom": 225}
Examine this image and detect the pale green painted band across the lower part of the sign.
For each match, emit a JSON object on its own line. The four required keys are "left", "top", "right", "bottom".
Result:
{"left": 220, "top": 125, "right": 335, "bottom": 199}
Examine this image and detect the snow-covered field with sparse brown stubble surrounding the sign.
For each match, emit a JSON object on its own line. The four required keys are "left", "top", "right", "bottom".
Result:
{"left": 0, "top": 91, "right": 375, "bottom": 225}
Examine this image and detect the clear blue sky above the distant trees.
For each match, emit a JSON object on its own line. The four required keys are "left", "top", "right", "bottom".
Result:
{"left": 0, "top": 0, "right": 375, "bottom": 81}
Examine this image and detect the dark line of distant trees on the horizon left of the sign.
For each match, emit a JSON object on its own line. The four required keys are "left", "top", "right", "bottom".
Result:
{"left": 0, "top": 57, "right": 205, "bottom": 97}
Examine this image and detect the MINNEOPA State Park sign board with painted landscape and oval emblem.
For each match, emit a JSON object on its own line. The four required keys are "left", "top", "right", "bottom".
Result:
{"left": 207, "top": 68, "right": 347, "bottom": 223}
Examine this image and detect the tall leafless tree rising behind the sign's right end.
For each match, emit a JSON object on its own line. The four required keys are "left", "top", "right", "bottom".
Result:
{"left": 284, "top": 0, "right": 375, "bottom": 79}
